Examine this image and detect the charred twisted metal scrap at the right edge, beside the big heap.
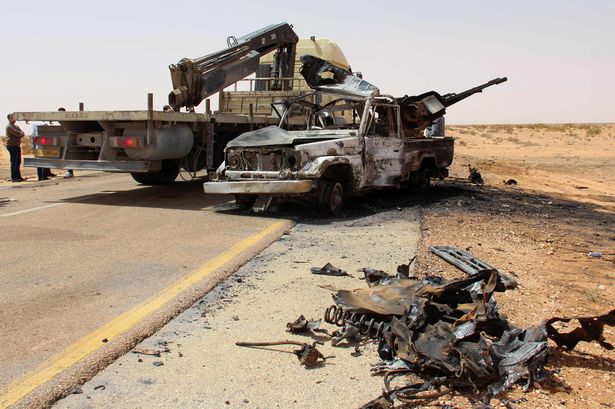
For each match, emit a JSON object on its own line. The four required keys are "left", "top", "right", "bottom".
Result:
{"left": 545, "top": 309, "right": 615, "bottom": 351}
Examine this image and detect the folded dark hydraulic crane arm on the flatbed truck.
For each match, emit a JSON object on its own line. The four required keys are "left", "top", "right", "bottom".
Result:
{"left": 169, "top": 23, "right": 299, "bottom": 111}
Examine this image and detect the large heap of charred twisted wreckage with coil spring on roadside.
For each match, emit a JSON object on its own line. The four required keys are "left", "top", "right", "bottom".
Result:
{"left": 325, "top": 263, "right": 548, "bottom": 403}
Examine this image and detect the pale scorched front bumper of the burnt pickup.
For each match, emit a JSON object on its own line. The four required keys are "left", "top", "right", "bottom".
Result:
{"left": 203, "top": 180, "right": 313, "bottom": 194}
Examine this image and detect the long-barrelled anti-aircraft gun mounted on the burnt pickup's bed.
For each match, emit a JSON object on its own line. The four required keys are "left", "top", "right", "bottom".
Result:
{"left": 397, "top": 77, "right": 508, "bottom": 138}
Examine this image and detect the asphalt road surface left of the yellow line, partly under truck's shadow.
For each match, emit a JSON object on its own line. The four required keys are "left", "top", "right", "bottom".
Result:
{"left": 0, "top": 172, "right": 290, "bottom": 402}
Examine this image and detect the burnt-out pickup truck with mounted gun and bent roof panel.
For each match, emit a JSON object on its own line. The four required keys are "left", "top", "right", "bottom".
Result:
{"left": 204, "top": 56, "right": 506, "bottom": 215}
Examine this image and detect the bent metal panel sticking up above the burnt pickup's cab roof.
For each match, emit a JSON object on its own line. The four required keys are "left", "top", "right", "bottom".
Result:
{"left": 300, "top": 55, "right": 380, "bottom": 98}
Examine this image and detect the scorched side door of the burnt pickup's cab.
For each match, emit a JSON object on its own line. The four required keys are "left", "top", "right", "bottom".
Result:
{"left": 363, "top": 103, "right": 404, "bottom": 186}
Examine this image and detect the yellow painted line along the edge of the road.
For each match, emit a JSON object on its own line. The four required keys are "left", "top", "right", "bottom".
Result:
{"left": 0, "top": 220, "right": 291, "bottom": 408}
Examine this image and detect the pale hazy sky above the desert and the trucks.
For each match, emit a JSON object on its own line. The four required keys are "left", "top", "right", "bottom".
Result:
{"left": 0, "top": 0, "right": 615, "bottom": 127}
